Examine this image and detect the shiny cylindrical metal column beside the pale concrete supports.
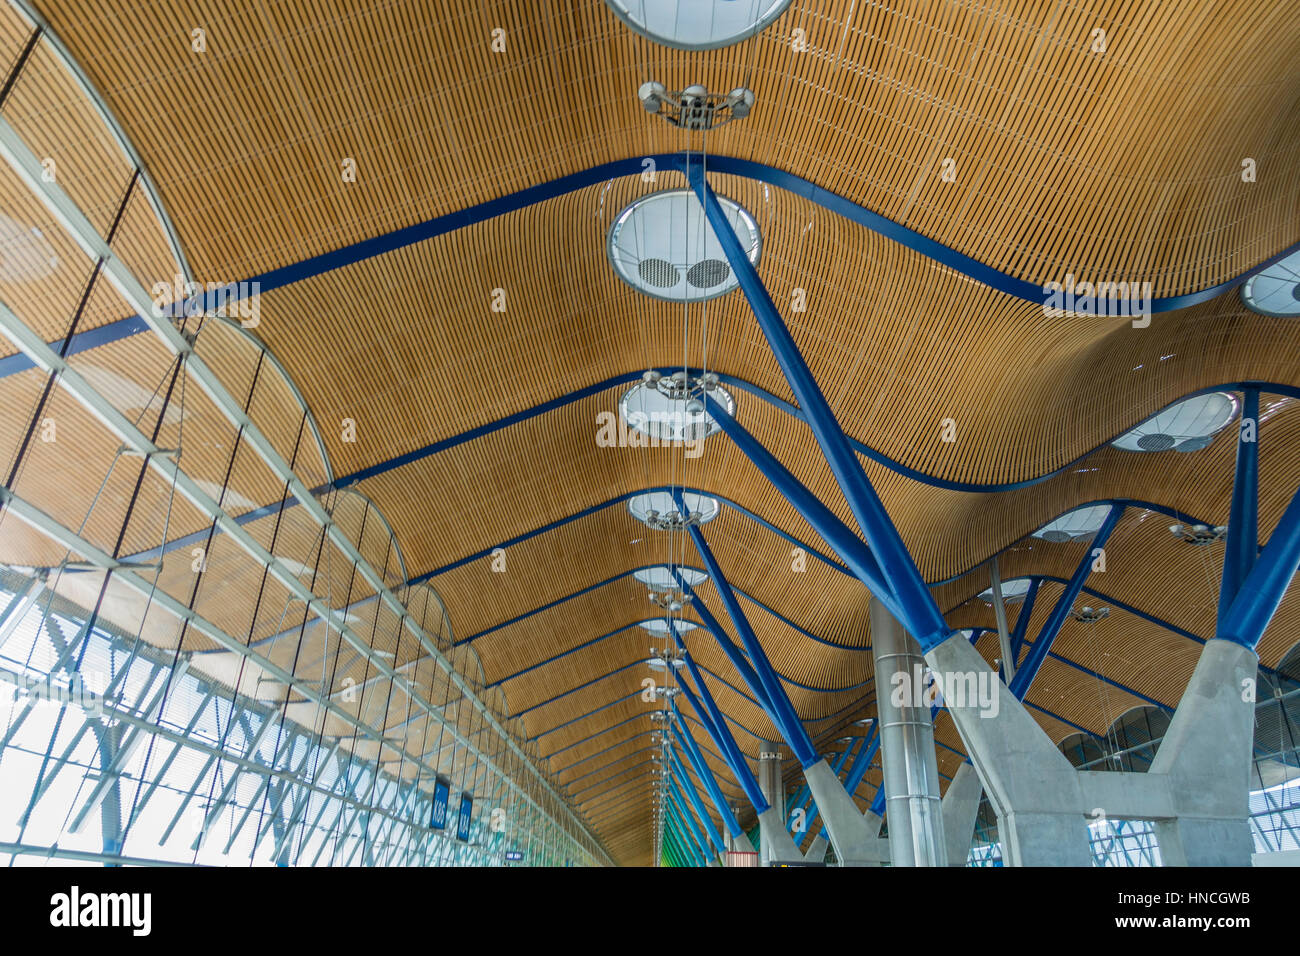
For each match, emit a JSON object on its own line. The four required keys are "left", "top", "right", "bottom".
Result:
{"left": 871, "top": 598, "right": 948, "bottom": 866}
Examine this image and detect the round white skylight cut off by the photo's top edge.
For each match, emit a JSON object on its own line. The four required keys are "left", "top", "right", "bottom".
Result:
{"left": 605, "top": 0, "right": 790, "bottom": 49}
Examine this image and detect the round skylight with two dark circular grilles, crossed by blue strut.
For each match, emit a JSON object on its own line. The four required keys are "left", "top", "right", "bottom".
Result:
{"left": 606, "top": 189, "right": 762, "bottom": 302}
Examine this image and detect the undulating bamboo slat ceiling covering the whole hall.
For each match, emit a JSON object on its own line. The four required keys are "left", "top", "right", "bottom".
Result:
{"left": 0, "top": 0, "right": 1300, "bottom": 864}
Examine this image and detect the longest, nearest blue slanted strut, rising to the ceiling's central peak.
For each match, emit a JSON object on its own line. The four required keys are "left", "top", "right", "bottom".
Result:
{"left": 686, "top": 163, "right": 950, "bottom": 652}
